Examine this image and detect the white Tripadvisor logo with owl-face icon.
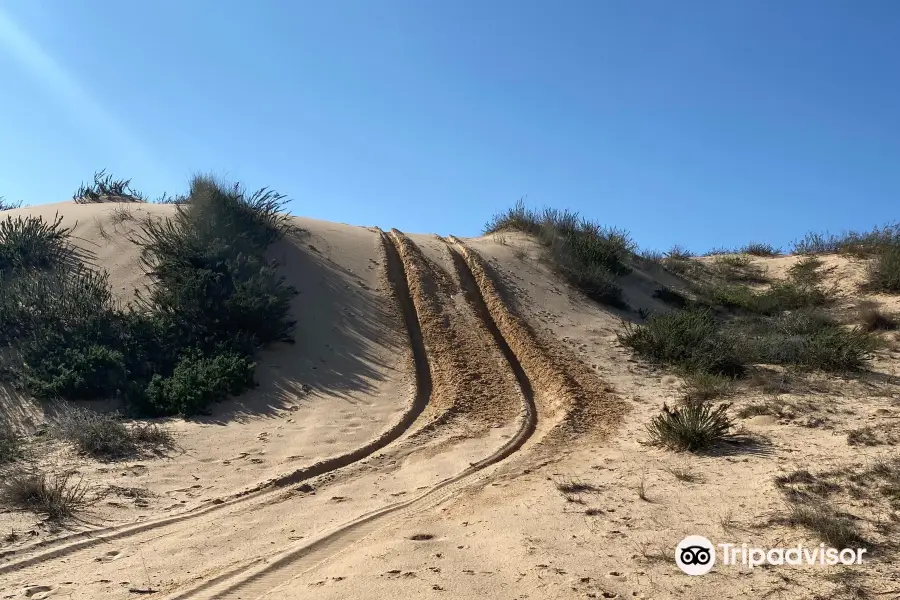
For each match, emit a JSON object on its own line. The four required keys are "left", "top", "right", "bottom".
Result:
{"left": 675, "top": 535, "right": 867, "bottom": 575}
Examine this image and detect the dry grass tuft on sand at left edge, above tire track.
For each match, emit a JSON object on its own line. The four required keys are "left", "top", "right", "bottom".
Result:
{"left": 0, "top": 467, "right": 88, "bottom": 520}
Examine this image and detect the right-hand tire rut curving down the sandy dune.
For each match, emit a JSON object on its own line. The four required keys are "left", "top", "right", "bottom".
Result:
{"left": 168, "top": 229, "right": 538, "bottom": 600}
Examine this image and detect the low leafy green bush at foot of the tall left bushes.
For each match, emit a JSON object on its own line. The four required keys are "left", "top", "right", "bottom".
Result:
{"left": 147, "top": 353, "right": 256, "bottom": 415}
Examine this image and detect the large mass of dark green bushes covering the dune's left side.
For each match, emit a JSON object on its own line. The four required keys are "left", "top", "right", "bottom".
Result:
{"left": 0, "top": 172, "right": 296, "bottom": 418}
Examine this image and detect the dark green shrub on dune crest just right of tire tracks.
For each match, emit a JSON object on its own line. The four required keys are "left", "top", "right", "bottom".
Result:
{"left": 484, "top": 201, "right": 636, "bottom": 306}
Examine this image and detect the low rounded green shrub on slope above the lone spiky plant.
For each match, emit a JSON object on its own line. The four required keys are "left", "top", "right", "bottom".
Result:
{"left": 619, "top": 310, "right": 744, "bottom": 377}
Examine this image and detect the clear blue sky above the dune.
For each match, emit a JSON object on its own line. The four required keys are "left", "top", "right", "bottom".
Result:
{"left": 0, "top": 0, "right": 900, "bottom": 251}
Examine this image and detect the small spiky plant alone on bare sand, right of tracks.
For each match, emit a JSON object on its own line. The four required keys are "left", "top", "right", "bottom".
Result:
{"left": 647, "top": 402, "right": 733, "bottom": 452}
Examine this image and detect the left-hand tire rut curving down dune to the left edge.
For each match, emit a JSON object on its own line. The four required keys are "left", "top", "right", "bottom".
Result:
{"left": 0, "top": 230, "right": 432, "bottom": 575}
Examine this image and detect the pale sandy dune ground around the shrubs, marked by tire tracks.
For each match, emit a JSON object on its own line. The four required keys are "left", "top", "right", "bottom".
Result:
{"left": 0, "top": 204, "right": 900, "bottom": 599}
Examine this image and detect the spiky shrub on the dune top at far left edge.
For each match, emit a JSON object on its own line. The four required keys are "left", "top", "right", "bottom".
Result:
{"left": 0, "top": 215, "right": 72, "bottom": 279}
